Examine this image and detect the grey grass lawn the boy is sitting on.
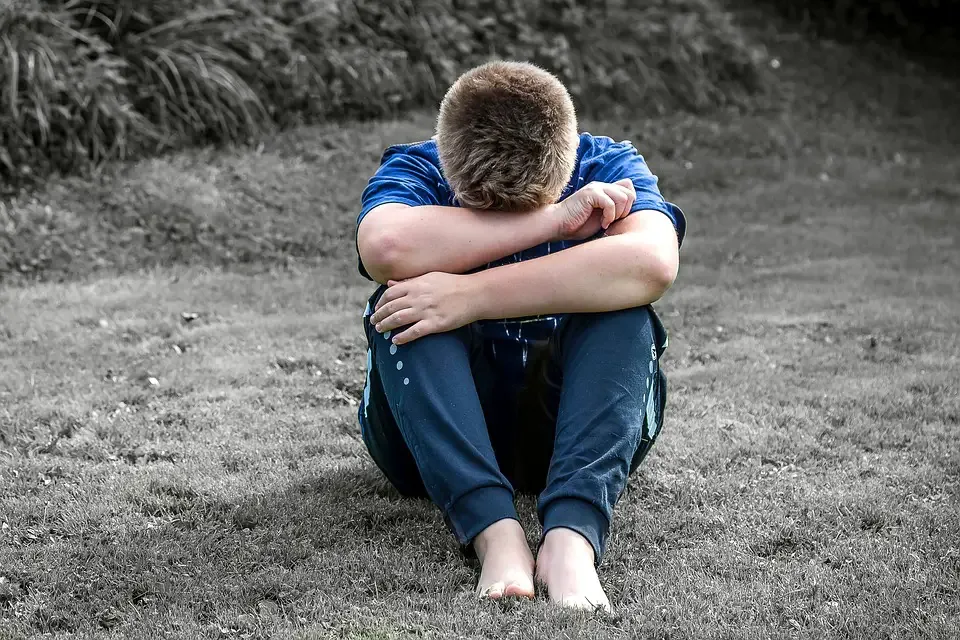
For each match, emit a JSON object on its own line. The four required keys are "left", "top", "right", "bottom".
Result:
{"left": 0, "top": 17, "right": 960, "bottom": 639}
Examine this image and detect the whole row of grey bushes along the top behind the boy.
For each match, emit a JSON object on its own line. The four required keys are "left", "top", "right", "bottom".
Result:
{"left": 0, "top": 0, "right": 762, "bottom": 183}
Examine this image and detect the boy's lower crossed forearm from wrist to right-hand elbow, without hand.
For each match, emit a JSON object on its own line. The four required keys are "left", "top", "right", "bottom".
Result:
{"left": 468, "top": 213, "right": 679, "bottom": 319}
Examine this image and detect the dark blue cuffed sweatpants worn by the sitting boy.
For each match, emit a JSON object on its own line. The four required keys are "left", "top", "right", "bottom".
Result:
{"left": 360, "top": 287, "right": 666, "bottom": 563}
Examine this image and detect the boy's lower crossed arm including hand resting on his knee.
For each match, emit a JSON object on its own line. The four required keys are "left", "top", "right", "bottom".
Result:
{"left": 372, "top": 210, "right": 679, "bottom": 344}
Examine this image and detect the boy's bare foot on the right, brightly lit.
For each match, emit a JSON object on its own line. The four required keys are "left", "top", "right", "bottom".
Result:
{"left": 537, "top": 528, "right": 612, "bottom": 613}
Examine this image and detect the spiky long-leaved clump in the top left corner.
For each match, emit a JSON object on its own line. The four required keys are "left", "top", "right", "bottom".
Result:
{"left": 0, "top": 0, "right": 155, "bottom": 178}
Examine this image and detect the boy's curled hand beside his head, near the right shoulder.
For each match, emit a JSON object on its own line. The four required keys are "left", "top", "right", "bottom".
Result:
{"left": 551, "top": 178, "right": 637, "bottom": 240}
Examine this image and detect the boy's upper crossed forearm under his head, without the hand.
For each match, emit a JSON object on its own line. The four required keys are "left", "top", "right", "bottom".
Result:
{"left": 357, "top": 205, "right": 557, "bottom": 282}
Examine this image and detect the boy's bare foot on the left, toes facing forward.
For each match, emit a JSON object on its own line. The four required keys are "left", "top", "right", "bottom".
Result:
{"left": 473, "top": 518, "right": 533, "bottom": 600}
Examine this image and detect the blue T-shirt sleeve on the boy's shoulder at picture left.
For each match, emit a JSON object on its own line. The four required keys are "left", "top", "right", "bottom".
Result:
{"left": 357, "top": 143, "right": 447, "bottom": 280}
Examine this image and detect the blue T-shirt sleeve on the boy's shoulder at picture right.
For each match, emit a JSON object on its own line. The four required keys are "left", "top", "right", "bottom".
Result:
{"left": 583, "top": 138, "right": 687, "bottom": 244}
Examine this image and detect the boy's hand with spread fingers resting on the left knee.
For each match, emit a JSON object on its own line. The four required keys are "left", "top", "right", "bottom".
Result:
{"left": 370, "top": 271, "right": 479, "bottom": 344}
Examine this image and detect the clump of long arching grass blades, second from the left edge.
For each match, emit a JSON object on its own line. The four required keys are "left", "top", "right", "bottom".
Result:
{"left": 64, "top": 0, "right": 276, "bottom": 144}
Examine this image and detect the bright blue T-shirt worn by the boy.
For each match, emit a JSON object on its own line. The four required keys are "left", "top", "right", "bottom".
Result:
{"left": 357, "top": 133, "right": 687, "bottom": 364}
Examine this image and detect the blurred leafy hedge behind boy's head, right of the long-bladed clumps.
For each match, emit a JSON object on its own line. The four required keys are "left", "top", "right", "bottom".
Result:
{"left": 284, "top": 0, "right": 761, "bottom": 115}
